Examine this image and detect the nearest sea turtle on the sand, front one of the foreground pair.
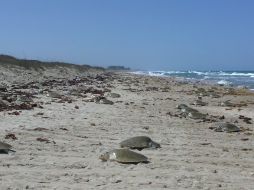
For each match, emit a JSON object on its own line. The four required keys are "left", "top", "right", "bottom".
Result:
{"left": 99, "top": 149, "right": 148, "bottom": 164}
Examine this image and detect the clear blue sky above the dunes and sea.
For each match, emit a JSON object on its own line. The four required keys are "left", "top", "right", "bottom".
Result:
{"left": 0, "top": 0, "right": 254, "bottom": 70}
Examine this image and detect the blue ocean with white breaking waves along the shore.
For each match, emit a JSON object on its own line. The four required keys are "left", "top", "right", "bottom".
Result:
{"left": 133, "top": 71, "right": 254, "bottom": 90}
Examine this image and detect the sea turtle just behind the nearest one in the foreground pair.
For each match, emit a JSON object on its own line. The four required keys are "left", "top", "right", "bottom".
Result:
{"left": 120, "top": 136, "right": 161, "bottom": 150}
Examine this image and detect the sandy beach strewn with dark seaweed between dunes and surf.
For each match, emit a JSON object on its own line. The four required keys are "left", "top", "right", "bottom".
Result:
{"left": 0, "top": 67, "right": 254, "bottom": 190}
